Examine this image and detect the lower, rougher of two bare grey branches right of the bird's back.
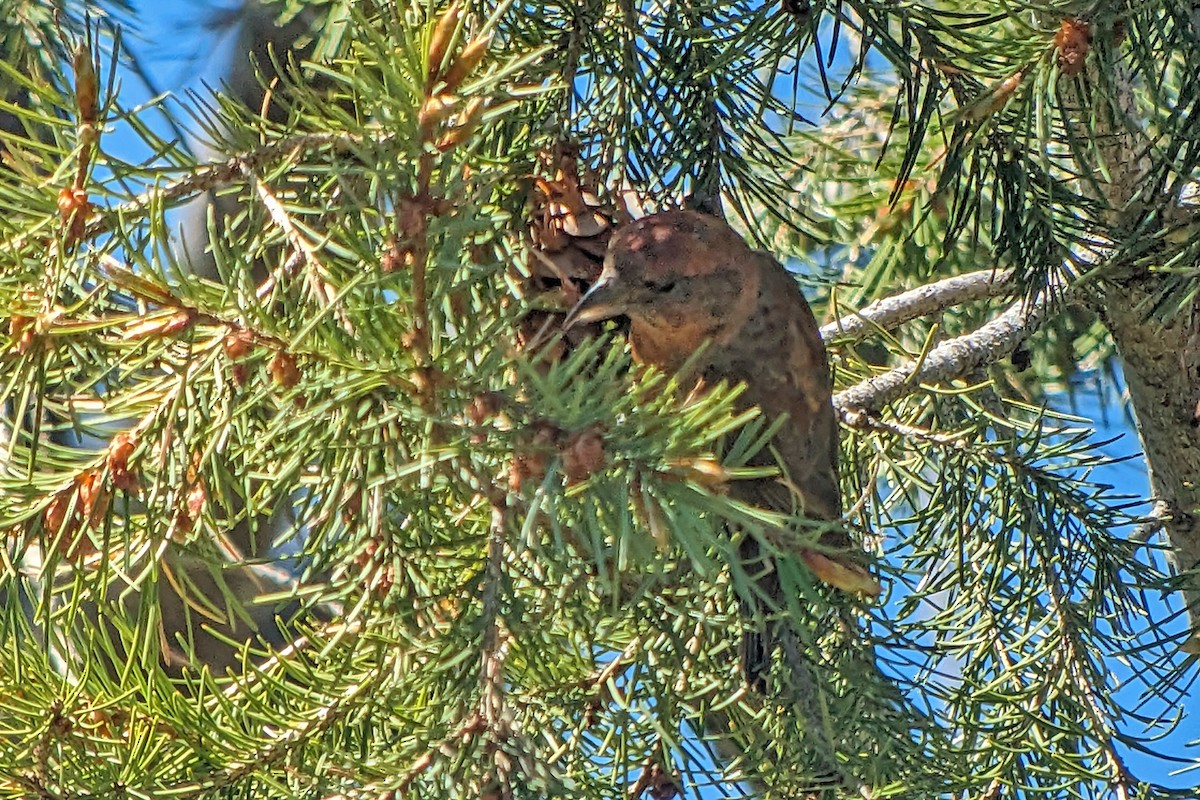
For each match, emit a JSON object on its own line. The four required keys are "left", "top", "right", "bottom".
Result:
{"left": 833, "top": 294, "right": 1051, "bottom": 425}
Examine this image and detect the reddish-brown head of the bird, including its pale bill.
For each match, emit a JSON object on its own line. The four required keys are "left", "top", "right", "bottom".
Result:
{"left": 563, "top": 211, "right": 758, "bottom": 338}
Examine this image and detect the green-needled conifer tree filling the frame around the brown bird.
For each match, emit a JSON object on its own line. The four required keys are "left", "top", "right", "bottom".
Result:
{"left": 0, "top": 0, "right": 1200, "bottom": 799}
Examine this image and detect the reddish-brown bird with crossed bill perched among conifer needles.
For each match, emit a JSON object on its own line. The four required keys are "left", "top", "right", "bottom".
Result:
{"left": 564, "top": 211, "right": 878, "bottom": 688}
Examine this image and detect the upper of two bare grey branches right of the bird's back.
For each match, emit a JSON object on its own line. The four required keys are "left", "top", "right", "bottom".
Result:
{"left": 821, "top": 269, "right": 1013, "bottom": 342}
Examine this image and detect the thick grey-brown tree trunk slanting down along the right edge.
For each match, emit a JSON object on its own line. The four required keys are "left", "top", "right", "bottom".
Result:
{"left": 1062, "top": 14, "right": 1200, "bottom": 650}
